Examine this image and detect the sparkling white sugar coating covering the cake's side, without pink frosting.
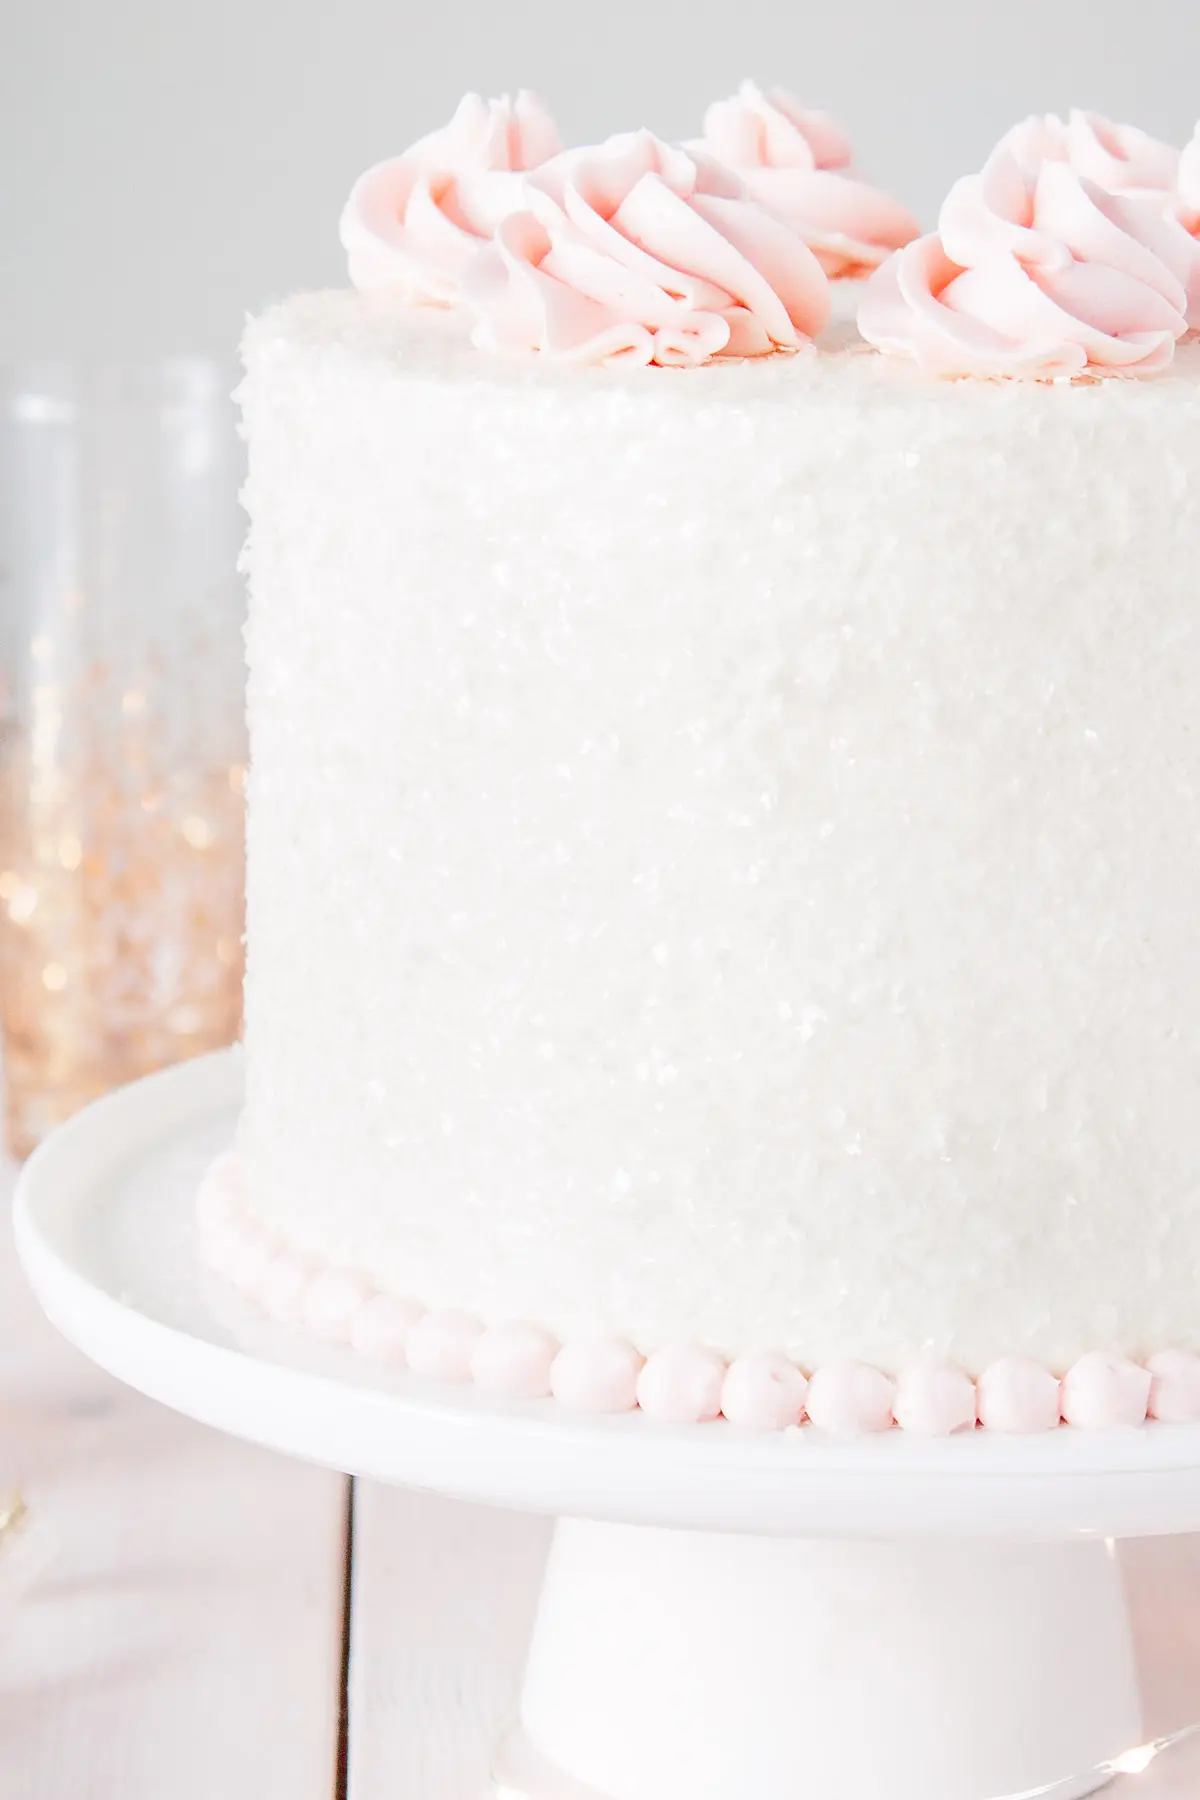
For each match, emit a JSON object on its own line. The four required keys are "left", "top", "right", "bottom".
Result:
{"left": 241, "top": 295, "right": 1200, "bottom": 1372}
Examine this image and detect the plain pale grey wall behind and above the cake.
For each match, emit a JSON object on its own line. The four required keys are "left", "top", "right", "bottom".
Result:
{"left": 0, "top": 0, "right": 1200, "bottom": 358}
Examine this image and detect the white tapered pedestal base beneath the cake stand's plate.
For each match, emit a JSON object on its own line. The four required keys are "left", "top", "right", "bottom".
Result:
{"left": 497, "top": 1519, "right": 1141, "bottom": 1800}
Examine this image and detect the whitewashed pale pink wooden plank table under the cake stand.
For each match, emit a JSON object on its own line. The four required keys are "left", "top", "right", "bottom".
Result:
{"left": 0, "top": 1170, "right": 1200, "bottom": 1800}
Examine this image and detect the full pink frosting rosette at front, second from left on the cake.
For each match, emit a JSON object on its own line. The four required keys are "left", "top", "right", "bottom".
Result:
{"left": 464, "top": 131, "right": 829, "bottom": 367}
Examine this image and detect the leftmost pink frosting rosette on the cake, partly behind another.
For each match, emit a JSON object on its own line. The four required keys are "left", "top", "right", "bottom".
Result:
{"left": 340, "top": 92, "right": 561, "bottom": 306}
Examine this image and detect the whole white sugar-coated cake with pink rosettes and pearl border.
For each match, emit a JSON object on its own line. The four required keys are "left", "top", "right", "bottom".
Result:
{"left": 201, "top": 88, "right": 1200, "bottom": 1431}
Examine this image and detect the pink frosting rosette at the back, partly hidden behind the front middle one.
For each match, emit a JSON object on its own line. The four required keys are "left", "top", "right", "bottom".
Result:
{"left": 696, "top": 81, "right": 919, "bottom": 277}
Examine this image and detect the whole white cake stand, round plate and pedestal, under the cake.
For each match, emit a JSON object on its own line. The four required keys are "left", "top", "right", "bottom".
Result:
{"left": 16, "top": 1053, "right": 1200, "bottom": 1800}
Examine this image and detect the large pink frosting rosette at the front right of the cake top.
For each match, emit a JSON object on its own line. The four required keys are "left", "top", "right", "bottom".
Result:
{"left": 858, "top": 148, "right": 1193, "bottom": 380}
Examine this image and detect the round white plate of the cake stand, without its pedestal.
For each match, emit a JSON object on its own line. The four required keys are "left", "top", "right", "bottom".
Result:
{"left": 14, "top": 1048, "right": 1200, "bottom": 1537}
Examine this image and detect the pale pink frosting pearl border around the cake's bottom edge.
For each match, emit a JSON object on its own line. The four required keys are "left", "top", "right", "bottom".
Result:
{"left": 196, "top": 1152, "right": 1200, "bottom": 1436}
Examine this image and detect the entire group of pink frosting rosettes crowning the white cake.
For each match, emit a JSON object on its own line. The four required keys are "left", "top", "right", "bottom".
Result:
{"left": 342, "top": 81, "right": 1200, "bottom": 382}
